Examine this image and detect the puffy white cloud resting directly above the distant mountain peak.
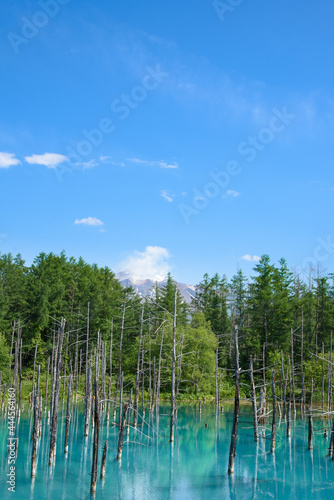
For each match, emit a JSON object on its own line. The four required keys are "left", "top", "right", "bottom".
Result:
{"left": 120, "top": 246, "right": 171, "bottom": 281}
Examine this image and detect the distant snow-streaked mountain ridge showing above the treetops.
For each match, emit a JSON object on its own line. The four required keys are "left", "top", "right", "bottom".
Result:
{"left": 116, "top": 272, "right": 196, "bottom": 304}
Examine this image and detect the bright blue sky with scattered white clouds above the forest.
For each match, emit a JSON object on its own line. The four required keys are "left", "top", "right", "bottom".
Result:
{"left": 0, "top": 0, "right": 334, "bottom": 283}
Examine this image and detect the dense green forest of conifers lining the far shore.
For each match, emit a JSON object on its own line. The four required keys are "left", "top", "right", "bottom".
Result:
{"left": 0, "top": 252, "right": 334, "bottom": 398}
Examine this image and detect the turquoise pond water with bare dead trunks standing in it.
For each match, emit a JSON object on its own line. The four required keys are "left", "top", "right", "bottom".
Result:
{"left": 0, "top": 404, "right": 334, "bottom": 500}
